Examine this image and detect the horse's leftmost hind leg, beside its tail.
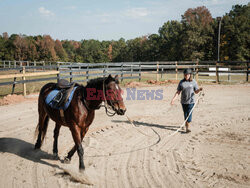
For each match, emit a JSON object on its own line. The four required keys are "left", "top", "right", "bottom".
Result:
{"left": 35, "top": 113, "right": 49, "bottom": 149}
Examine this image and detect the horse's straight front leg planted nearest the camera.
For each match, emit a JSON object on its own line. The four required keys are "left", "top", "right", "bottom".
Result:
{"left": 70, "top": 125, "right": 85, "bottom": 171}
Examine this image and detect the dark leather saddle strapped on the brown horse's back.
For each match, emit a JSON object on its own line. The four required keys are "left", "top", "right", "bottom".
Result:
{"left": 50, "top": 79, "right": 78, "bottom": 109}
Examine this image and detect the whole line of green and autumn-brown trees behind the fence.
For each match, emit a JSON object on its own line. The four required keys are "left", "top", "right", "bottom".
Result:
{"left": 0, "top": 3, "right": 250, "bottom": 63}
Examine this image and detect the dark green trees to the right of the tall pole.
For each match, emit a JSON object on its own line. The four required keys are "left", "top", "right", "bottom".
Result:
{"left": 222, "top": 3, "right": 250, "bottom": 61}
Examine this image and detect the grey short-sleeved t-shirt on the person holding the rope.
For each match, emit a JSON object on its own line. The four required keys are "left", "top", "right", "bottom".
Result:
{"left": 177, "top": 79, "right": 198, "bottom": 104}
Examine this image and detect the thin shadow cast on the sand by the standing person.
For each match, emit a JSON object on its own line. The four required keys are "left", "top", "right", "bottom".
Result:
{"left": 112, "top": 120, "right": 186, "bottom": 134}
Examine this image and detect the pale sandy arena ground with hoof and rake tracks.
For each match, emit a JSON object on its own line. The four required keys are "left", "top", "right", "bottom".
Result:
{"left": 0, "top": 84, "right": 250, "bottom": 188}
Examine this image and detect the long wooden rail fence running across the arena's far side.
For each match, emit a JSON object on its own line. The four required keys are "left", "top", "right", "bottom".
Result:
{"left": 0, "top": 60, "right": 250, "bottom": 95}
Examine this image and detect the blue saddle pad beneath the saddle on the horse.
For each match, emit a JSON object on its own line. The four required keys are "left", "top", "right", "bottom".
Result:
{"left": 45, "top": 86, "right": 77, "bottom": 110}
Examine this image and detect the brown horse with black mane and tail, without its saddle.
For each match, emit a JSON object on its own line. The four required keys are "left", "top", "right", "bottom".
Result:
{"left": 35, "top": 75, "right": 126, "bottom": 170}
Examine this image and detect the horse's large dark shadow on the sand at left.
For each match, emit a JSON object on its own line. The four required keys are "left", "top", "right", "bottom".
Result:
{"left": 0, "top": 138, "right": 60, "bottom": 169}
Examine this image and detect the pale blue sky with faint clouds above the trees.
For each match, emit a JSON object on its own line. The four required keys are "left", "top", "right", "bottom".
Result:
{"left": 0, "top": 0, "right": 249, "bottom": 41}
